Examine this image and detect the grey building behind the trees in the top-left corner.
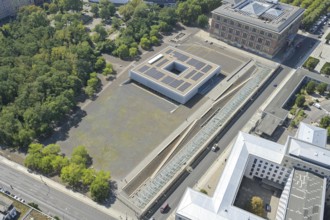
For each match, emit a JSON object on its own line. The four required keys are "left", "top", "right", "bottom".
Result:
{"left": 0, "top": 0, "right": 34, "bottom": 19}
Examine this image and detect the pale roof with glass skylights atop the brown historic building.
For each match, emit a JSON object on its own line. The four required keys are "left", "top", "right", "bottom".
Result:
{"left": 213, "top": 0, "right": 304, "bottom": 33}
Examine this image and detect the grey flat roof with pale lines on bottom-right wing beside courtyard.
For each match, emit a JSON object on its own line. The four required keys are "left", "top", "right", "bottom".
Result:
{"left": 285, "top": 170, "right": 326, "bottom": 220}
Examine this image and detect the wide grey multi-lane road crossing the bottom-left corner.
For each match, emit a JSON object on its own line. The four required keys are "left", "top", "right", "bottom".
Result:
{"left": 0, "top": 164, "right": 114, "bottom": 220}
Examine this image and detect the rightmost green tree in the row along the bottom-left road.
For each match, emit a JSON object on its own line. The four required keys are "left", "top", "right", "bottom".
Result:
{"left": 90, "top": 171, "right": 110, "bottom": 202}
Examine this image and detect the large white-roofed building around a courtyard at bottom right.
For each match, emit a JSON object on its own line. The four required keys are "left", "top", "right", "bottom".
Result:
{"left": 176, "top": 123, "right": 330, "bottom": 220}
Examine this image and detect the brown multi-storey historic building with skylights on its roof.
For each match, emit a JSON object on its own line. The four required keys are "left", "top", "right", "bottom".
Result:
{"left": 210, "top": 0, "right": 304, "bottom": 58}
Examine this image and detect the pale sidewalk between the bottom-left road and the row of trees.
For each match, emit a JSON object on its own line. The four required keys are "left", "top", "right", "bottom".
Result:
{"left": 0, "top": 156, "right": 136, "bottom": 219}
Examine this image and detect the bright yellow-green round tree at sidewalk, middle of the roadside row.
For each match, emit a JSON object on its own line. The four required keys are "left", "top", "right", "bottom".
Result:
{"left": 61, "top": 163, "right": 84, "bottom": 187}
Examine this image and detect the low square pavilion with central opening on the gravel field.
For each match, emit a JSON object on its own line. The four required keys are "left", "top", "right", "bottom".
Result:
{"left": 129, "top": 47, "right": 220, "bottom": 104}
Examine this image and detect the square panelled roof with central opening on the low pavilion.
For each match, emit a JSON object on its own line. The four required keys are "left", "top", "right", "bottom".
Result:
{"left": 131, "top": 47, "right": 220, "bottom": 95}
